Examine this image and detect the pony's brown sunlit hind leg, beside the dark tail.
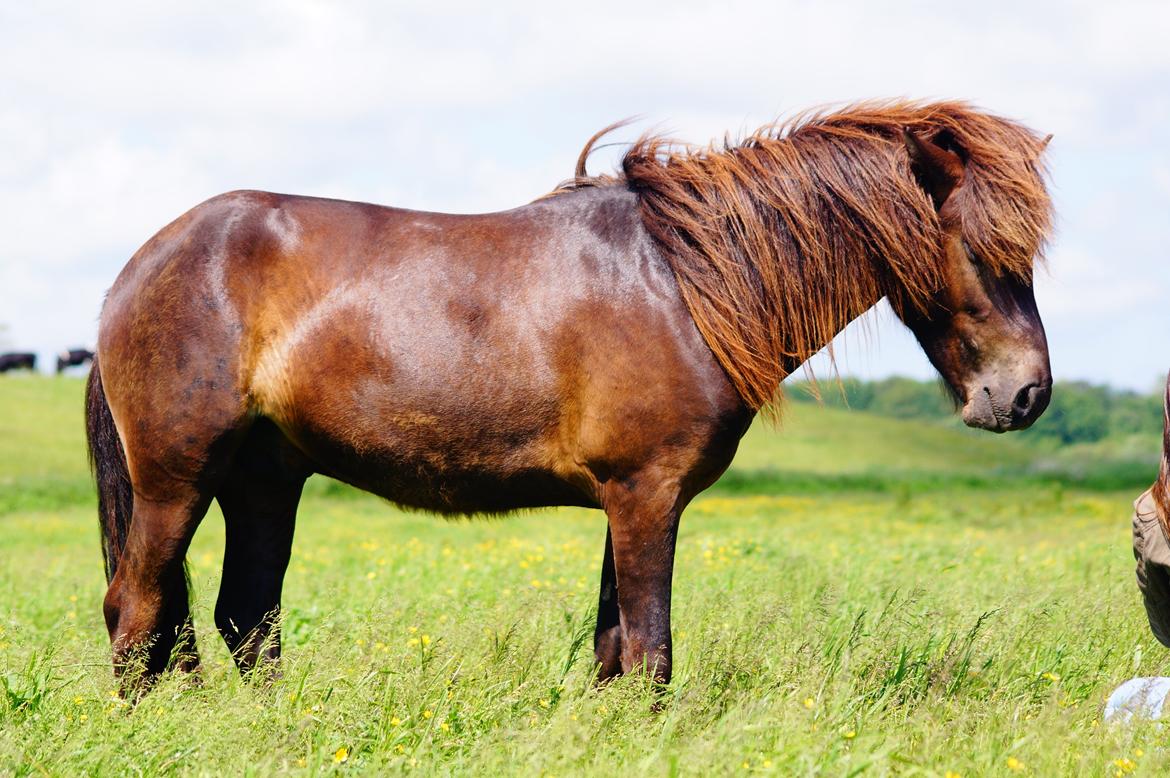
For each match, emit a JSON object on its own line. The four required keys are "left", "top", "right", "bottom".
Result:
{"left": 102, "top": 360, "right": 249, "bottom": 693}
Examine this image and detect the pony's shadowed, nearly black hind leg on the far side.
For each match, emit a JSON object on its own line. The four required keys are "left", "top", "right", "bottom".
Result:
{"left": 215, "top": 420, "right": 310, "bottom": 675}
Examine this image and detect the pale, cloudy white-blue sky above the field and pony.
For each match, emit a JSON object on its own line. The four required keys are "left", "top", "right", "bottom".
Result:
{"left": 0, "top": 0, "right": 1170, "bottom": 390}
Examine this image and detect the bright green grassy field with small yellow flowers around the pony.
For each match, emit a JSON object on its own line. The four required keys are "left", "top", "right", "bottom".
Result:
{"left": 0, "top": 378, "right": 1170, "bottom": 776}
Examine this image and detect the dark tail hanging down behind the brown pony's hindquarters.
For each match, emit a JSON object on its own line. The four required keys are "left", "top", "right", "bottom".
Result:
{"left": 85, "top": 357, "right": 133, "bottom": 583}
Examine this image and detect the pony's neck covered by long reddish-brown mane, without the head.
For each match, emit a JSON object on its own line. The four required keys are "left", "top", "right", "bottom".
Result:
{"left": 625, "top": 133, "right": 940, "bottom": 408}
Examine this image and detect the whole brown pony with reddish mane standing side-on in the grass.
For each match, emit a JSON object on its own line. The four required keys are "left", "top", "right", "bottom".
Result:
{"left": 87, "top": 102, "right": 1051, "bottom": 681}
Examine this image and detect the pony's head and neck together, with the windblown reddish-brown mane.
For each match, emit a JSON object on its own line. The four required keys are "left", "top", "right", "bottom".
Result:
{"left": 560, "top": 101, "right": 1052, "bottom": 421}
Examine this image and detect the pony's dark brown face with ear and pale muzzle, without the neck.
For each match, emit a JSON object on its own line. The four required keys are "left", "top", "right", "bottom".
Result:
{"left": 892, "top": 129, "right": 1052, "bottom": 432}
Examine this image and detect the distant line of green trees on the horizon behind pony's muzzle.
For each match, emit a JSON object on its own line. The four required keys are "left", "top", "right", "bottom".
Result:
{"left": 785, "top": 378, "right": 1162, "bottom": 443}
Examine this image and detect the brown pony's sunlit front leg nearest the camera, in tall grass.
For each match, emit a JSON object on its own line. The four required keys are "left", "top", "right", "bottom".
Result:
{"left": 605, "top": 478, "right": 681, "bottom": 683}
